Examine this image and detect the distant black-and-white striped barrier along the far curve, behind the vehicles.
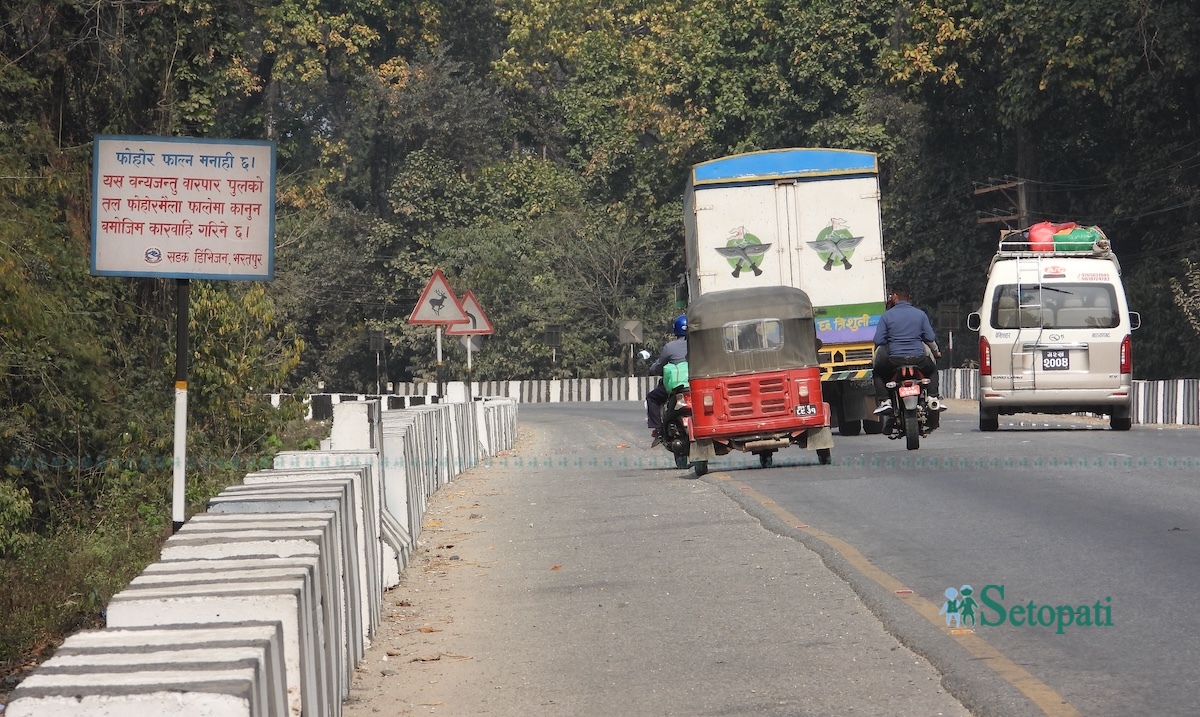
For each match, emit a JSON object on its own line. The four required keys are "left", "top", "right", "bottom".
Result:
{"left": 290, "top": 368, "right": 1200, "bottom": 426}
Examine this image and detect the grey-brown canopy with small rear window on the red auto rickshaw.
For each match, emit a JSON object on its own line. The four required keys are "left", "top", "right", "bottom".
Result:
{"left": 688, "top": 287, "right": 817, "bottom": 378}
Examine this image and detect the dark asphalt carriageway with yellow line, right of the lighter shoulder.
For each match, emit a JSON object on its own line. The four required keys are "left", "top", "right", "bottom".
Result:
{"left": 520, "top": 402, "right": 1200, "bottom": 717}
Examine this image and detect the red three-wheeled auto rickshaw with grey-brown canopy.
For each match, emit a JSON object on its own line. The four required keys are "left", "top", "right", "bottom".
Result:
{"left": 677, "top": 287, "right": 833, "bottom": 476}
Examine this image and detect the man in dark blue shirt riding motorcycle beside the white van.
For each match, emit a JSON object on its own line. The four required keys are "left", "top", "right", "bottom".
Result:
{"left": 875, "top": 284, "right": 946, "bottom": 426}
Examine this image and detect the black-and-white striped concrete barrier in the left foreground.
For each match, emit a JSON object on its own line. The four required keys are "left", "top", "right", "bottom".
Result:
{"left": 0, "top": 398, "right": 517, "bottom": 717}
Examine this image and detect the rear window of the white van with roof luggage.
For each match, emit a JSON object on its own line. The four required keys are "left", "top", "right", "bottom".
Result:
{"left": 990, "top": 283, "right": 1120, "bottom": 329}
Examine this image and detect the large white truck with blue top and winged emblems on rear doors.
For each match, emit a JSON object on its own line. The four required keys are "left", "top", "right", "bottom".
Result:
{"left": 684, "top": 149, "right": 887, "bottom": 435}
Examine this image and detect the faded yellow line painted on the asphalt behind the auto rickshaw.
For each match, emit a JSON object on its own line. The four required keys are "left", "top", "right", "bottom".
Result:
{"left": 713, "top": 474, "right": 1081, "bottom": 717}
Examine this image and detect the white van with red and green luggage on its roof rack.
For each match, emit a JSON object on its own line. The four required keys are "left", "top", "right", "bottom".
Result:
{"left": 967, "top": 228, "right": 1141, "bottom": 430}
